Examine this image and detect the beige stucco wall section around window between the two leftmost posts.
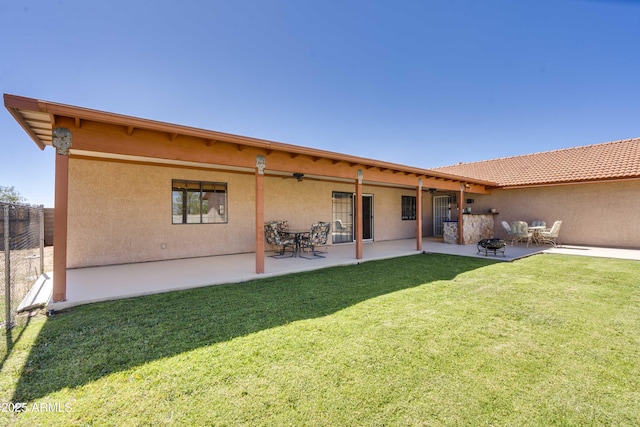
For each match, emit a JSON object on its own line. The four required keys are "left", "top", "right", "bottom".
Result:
{"left": 67, "top": 159, "right": 254, "bottom": 268}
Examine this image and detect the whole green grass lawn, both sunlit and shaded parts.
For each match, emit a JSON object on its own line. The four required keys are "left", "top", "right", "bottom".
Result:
{"left": 0, "top": 254, "right": 640, "bottom": 426}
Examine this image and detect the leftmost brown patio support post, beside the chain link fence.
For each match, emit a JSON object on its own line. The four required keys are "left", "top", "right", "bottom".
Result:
{"left": 52, "top": 128, "right": 71, "bottom": 302}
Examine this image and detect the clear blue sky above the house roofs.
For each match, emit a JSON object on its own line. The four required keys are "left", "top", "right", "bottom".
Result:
{"left": 0, "top": 0, "right": 640, "bottom": 206}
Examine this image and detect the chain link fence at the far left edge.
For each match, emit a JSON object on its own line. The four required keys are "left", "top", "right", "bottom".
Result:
{"left": 0, "top": 202, "right": 51, "bottom": 329}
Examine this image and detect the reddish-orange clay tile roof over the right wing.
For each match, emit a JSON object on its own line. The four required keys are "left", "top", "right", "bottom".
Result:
{"left": 433, "top": 138, "right": 640, "bottom": 187}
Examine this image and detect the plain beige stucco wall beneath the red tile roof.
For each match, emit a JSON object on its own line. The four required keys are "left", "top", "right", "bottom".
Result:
{"left": 469, "top": 181, "right": 640, "bottom": 248}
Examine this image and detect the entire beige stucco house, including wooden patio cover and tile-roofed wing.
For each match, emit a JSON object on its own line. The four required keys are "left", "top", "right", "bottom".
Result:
{"left": 4, "top": 94, "right": 640, "bottom": 301}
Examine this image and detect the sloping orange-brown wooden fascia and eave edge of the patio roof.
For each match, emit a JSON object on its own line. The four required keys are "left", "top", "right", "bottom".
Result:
{"left": 4, "top": 94, "right": 498, "bottom": 193}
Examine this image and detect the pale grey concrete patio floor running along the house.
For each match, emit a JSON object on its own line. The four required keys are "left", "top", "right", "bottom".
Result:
{"left": 26, "top": 238, "right": 640, "bottom": 311}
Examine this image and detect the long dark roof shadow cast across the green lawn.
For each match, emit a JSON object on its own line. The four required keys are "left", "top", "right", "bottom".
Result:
{"left": 13, "top": 254, "right": 494, "bottom": 402}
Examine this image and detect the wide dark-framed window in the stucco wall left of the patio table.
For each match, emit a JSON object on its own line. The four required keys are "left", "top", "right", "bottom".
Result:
{"left": 171, "top": 179, "right": 227, "bottom": 224}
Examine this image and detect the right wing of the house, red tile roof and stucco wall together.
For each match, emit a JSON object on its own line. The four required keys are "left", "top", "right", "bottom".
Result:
{"left": 434, "top": 138, "right": 640, "bottom": 248}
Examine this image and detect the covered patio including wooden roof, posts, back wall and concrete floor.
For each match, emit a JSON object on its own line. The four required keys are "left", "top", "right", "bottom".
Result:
{"left": 4, "top": 94, "right": 640, "bottom": 310}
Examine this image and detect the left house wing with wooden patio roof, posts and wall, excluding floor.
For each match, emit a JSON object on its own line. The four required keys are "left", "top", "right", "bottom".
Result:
{"left": 4, "top": 94, "right": 494, "bottom": 302}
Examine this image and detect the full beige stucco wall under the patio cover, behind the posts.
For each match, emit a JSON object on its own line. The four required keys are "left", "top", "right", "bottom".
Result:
{"left": 67, "top": 158, "right": 430, "bottom": 268}
